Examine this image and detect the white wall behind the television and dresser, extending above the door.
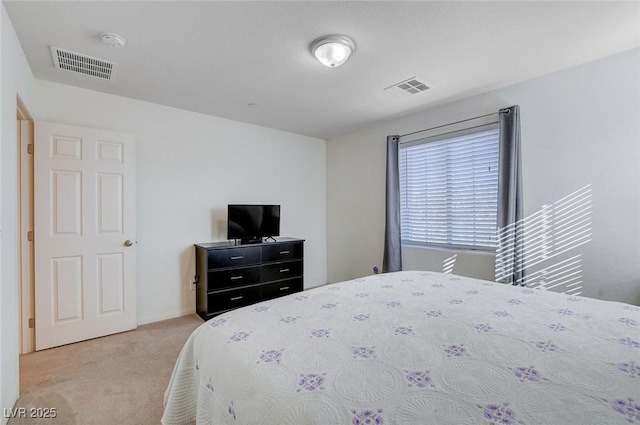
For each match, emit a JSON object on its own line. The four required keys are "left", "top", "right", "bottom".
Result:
{"left": 32, "top": 80, "right": 326, "bottom": 324}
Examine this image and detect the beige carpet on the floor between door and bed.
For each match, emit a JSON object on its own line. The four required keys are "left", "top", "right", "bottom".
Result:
{"left": 9, "top": 315, "right": 202, "bottom": 425}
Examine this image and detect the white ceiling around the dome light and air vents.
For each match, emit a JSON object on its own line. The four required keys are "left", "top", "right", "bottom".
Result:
{"left": 3, "top": 1, "right": 640, "bottom": 138}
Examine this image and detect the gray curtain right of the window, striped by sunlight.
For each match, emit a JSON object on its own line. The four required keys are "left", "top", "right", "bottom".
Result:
{"left": 496, "top": 105, "right": 525, "bottom": 286}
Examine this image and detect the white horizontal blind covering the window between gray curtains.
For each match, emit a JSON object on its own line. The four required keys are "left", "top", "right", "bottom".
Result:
{"left": 399, "top": 124, "right": 499, "bottom": 249}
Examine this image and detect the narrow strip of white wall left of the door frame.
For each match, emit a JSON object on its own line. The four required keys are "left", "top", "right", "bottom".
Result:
{"left": 0, "top": 4, "right": 33, "bottom": 423}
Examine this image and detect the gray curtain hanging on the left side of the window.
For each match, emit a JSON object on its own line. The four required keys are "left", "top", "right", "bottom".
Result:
{"left": 382, "top": 136, "right": 402, "bottom": 273}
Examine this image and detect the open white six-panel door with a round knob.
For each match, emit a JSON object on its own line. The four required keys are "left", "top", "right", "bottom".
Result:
{"left": 34, "top": 122, "right": 136, "bottom": 350}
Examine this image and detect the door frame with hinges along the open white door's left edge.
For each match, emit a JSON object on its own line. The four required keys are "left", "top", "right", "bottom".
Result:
{"left": 16, "top": 95, "right": 36, "bottom": 354}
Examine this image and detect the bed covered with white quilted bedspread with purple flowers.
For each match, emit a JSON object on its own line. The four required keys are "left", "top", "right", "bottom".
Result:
{"left": 162, "top": 271, "right": 640, "bottom": 425}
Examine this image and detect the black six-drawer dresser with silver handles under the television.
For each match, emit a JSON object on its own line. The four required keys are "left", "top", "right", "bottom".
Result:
{"left": 195, "top": 238, "right": 304, "bottom": 320}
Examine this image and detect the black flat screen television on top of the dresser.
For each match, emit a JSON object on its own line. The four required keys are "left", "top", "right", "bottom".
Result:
{"left": 227, "top": 204, "right": 280, "bottom": 243}
